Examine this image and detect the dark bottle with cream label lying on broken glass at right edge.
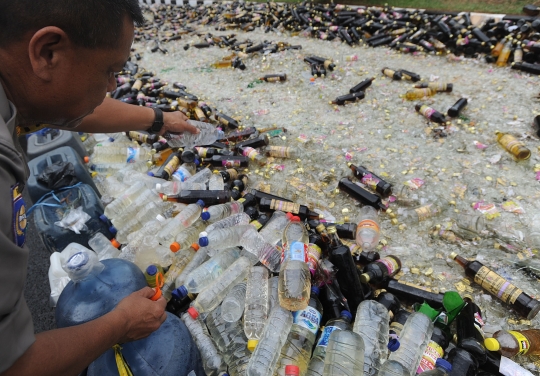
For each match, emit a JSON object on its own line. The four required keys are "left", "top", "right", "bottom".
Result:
{"left": 450, "top": 252, "right": 540, "bottom": 320}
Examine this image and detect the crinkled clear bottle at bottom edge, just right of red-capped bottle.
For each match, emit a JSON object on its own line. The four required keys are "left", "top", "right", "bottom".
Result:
{"left": 206, "top": 306, "right": 251, "bottom": 376}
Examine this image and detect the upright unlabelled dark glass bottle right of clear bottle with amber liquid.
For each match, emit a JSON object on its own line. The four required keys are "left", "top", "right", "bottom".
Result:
{"left": 323, "top": 227, "right": 364, "bottom": 315}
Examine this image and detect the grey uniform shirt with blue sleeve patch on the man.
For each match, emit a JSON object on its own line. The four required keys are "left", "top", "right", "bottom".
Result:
{"left": 0, "top": 85, "right": 35, "bottom": 373}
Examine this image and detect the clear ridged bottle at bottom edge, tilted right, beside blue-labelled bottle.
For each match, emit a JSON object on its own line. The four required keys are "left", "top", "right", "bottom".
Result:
{"left": 246, "top": 306, "right": 293, "bottom": 376}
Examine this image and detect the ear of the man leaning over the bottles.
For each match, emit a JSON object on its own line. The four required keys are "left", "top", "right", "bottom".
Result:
{"left": 28, "top": 26, "right": 70, "bottom": 81}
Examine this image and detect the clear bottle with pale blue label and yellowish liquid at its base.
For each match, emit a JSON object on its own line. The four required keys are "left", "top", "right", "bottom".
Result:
{"left": 278, "top": 220, "right": 311, "bottom": 311}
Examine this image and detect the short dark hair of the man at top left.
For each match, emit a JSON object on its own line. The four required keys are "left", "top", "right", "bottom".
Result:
{"left": 0, "top": 0, "right": 144, "bottom": 48}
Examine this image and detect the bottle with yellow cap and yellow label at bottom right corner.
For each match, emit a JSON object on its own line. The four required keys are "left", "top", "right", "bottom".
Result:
{"left": 484, "top": 329, "right": 540, "bottom": 358}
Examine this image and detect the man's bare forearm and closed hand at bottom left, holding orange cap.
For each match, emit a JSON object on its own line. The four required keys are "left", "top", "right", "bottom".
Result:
{"left": 1, "top": 287, "right": 167, "bottom": 376}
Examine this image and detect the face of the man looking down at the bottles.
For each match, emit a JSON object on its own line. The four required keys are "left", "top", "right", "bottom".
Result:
{"left": 44, "top": 17, "right": 133, "bottom": 128}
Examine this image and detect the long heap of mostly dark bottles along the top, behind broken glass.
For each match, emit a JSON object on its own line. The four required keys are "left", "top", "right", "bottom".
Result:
{"left": 135, "top": 1, "right": 540, "bottom": 74}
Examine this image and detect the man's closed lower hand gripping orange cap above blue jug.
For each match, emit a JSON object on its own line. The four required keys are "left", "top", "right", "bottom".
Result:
{"left": 113, "top": 287, "right": 167, "bottom": 343}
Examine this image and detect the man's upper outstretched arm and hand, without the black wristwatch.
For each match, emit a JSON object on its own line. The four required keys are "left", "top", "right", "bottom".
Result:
{"left": 73, "top": 98, "right": 198, "bottom": 134}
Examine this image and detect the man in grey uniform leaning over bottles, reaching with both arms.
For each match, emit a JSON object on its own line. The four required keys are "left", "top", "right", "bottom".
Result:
{"left": 0, "top": 0, "right": 197, "bottom": 376}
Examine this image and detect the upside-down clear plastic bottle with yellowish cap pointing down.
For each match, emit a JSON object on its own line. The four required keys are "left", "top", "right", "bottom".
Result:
{"left": 244, "top": 266, "right": 268, "bottom": 351}
